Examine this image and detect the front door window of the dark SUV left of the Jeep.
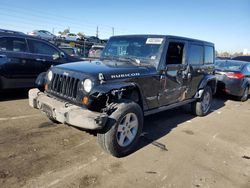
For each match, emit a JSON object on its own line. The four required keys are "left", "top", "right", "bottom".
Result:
{"left": 28, "top": 40, "right": 59, "bottom": 56}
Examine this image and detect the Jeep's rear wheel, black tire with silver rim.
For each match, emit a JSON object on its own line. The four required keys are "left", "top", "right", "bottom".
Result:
{"left": 191, "top": 86, "right": 212, "bottom": 116}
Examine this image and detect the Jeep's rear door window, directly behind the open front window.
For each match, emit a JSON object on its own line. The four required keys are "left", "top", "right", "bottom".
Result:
{"left": 188, "top": 44, "right": 203, "bottom": 65}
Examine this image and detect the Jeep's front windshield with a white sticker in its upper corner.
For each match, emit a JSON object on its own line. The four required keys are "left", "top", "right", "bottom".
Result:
{"left": 102, "top": 36, "right": 164, "bottom": 64}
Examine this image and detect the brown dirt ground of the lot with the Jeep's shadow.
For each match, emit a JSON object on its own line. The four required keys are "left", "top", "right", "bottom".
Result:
{"left": 0, "top": 91, "right": 250, "bottom": 188}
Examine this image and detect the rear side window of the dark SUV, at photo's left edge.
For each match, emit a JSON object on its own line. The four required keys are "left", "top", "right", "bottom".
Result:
{"left": 0, "top": 37, "right": 27, "bottom": 52}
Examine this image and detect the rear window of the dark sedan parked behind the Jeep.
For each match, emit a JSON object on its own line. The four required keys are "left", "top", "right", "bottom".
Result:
{"left": 215, "top": 61, "right": 243, "bottom": 71}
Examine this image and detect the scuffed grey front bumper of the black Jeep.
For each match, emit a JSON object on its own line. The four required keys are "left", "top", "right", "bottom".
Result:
{"left": 29, "top": 89, "right": 108, "bottom": 130}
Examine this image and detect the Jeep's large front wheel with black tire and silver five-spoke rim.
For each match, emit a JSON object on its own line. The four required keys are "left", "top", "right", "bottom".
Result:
{"left": 97, "top": 101, "right": 143, "bottom": 157}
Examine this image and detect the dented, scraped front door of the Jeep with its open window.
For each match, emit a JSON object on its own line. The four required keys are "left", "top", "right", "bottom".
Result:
{"left": 159, "top": 40, "right": 191, "bottom": 106}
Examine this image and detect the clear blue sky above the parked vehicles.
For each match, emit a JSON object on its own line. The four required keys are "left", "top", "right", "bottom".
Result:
{"left": 0, "top": 0, "right": 250, "bottom": 52}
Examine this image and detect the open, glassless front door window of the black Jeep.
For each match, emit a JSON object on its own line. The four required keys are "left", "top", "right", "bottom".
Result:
{"left": 166, "top": 42, "right": 184, "bottom": 65}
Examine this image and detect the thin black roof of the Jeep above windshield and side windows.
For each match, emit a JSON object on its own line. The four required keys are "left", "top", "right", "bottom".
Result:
{"left": 111, "top": 34, "right": 214, "bottom": 46}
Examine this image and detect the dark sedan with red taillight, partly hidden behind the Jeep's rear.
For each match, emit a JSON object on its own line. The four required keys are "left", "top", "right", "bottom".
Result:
{"left": 215, "top": 60, "right": 250, "bottom": 101}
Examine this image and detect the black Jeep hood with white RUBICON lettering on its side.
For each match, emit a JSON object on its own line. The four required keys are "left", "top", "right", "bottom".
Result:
{"left": 52, "top": 60, "right": 156, "bottom": 80}
